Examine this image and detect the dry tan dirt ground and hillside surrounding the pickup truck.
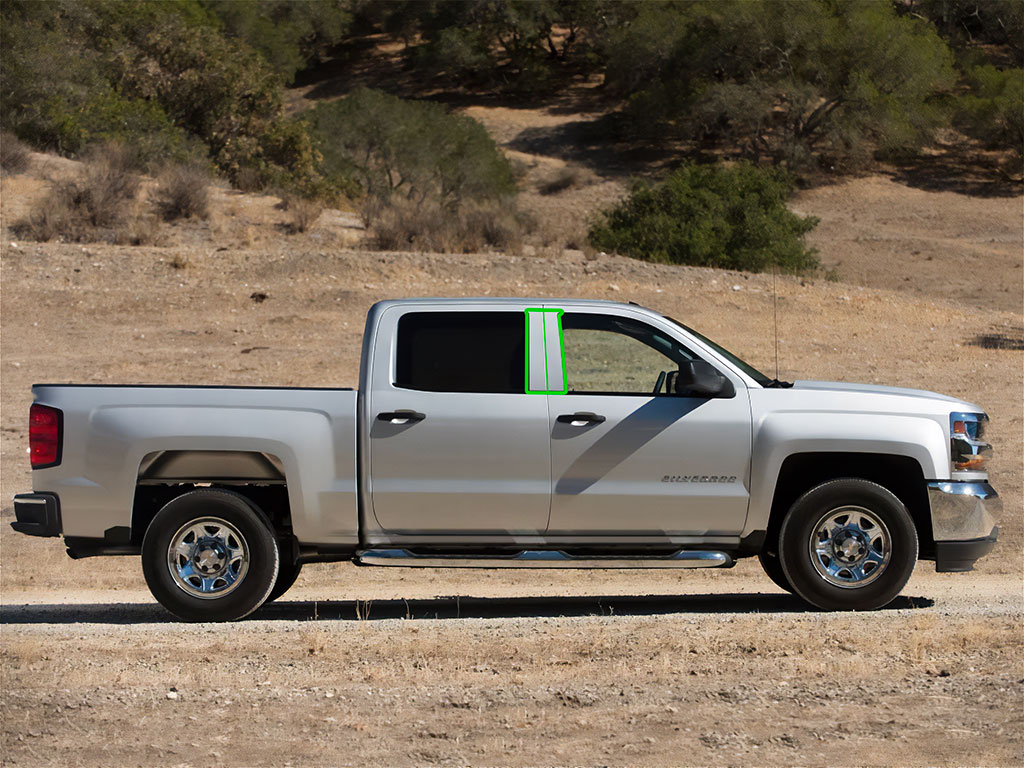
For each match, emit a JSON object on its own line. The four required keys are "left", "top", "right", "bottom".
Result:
{"left": 0, "top": 100, "right": 1024, "bottom": 766}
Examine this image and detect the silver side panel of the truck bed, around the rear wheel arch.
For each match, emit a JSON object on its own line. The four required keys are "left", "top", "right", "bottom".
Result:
{"left": 33, "top": 386, "right": 358, "bottom": 545}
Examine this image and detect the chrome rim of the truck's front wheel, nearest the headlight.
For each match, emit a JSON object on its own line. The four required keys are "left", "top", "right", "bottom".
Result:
{"left": 808, "top": 507, "right": 892, "bottom": 589}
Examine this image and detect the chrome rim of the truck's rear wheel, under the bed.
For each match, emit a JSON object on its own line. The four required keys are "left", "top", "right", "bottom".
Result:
{"left": 167, "top": 517, "right": 249, "bottom": 600}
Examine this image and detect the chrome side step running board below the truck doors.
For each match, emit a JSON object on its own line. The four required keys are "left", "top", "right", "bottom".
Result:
{"left": 354, "top": 549, "right": 733, "bottom": 568}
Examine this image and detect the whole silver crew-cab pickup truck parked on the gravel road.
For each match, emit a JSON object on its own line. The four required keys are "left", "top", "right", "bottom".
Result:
{"left": 12, "top": 299, "right": 1000, "bottom": 621}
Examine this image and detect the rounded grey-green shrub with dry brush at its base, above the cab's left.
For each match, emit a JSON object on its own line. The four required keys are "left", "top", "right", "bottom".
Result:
{"left": 306, "top": 88, "right": 526, "bottom": 251}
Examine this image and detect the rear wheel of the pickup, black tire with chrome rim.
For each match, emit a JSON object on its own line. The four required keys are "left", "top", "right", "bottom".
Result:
{"left": 142, "top": 488, "right": 281, "bottom": 622}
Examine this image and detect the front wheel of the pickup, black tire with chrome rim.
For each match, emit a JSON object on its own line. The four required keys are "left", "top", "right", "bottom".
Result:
{"left": 778, "top": 478, "right": 918, "bottom": 610}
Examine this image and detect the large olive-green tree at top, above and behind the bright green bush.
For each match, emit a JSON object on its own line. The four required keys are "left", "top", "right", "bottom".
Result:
{"left": 603, "top": 0, "right": 955, "bottom": 168}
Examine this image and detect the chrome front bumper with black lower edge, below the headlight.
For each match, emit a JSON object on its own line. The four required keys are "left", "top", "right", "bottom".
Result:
{"left": 928, "top": 480, "right": 1002, "bottom": 573}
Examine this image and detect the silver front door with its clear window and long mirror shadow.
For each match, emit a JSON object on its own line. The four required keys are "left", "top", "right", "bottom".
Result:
{"left": 548, "top": 309, "right": 751, "bottom": 538}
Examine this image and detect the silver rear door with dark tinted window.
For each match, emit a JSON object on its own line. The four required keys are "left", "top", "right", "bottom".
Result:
{"left": 369, "top": 303, "right": 551, "bottom": 536}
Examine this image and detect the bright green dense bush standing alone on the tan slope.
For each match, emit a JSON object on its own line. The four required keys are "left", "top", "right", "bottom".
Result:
{"left": 590, "top": 163, "right": 818, "bottom": 272}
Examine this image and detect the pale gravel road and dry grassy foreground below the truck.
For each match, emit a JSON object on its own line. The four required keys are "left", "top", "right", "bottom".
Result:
{"left": 0, "top": 561, "right": 1024, "bottom": 766}
